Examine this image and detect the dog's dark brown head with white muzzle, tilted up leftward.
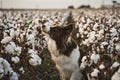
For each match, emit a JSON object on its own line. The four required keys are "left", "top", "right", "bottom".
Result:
{"left": 42, "top": 24, "right": 73, "bottom": 47}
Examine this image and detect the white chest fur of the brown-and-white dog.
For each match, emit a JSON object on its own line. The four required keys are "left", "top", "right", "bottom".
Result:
{"left": 48, "top": 39, "right": 80, "bottom": 78}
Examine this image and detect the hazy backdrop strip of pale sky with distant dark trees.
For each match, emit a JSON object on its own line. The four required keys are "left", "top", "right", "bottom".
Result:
{"left": 0, "top": 0, "right": 120, "bottom": 9}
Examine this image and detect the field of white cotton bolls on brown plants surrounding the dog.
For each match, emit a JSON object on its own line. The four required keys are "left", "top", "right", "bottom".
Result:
{"left": 0, "top": 9, "right": 120, "bottom": 80}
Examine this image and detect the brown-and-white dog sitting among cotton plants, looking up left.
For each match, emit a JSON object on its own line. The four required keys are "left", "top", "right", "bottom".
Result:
{"left": 41, "top": 13, "right": 87, "bottom": 80}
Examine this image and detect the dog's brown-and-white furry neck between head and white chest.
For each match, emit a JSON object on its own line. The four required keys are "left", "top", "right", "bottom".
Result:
{"left": 48, "top": 36, "right": 77, "bottom": 56}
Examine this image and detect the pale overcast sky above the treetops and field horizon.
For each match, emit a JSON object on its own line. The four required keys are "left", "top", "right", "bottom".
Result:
{"left": 0, "top": 0, "right": 119, "bottom": 9}
